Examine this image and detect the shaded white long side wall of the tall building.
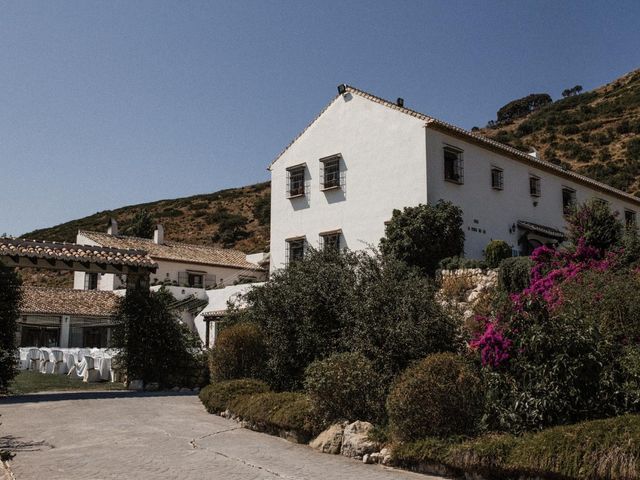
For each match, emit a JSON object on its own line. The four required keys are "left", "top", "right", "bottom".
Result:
{"left": 426, "top": 125, "right": 640, "bottom": 258}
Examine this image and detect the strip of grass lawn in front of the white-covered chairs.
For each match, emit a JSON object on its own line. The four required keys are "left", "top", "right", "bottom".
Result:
{"left": 9, "top": 371, "right": 125, "bottom": 395}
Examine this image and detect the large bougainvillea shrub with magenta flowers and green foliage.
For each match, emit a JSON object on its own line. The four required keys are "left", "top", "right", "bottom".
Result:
{"left": 469, "top": 234, "right": 640, "bottom": 433}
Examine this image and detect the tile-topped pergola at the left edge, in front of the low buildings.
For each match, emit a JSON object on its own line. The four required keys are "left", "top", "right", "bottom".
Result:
{"left": 0, "top": 237, "right": 158, "bottom": 290}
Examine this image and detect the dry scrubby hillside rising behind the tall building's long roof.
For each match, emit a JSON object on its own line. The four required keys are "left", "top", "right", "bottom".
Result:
{"left": 479, "top": 70, "right": 640, "bottom": 195}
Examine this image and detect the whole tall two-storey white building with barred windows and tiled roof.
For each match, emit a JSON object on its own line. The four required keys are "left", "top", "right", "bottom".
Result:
{"left": 269, "top": 85, "right": 640, "bottom": 270}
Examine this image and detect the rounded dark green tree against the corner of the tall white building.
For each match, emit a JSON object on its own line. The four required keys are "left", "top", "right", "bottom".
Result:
{"left": 380, "top": 200, "right": 464, "bottom": 275}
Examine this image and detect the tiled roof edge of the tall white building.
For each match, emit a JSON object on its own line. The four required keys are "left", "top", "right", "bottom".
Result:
{"left": 269, "top": 85, "right": 640, "bottom": 206}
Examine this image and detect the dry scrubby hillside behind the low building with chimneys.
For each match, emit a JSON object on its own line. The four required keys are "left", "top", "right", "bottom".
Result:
{"left": 21, "top": 182, "right": 271, "bottom": 287}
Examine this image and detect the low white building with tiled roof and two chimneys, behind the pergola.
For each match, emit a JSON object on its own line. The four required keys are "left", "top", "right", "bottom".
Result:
{"left": 73, "top": 220, "right": 268, "bottom": 290}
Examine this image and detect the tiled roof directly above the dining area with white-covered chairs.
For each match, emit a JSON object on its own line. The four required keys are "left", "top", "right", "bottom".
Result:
{"left": 20, "top": 286, "right": 119, "bottom": 317}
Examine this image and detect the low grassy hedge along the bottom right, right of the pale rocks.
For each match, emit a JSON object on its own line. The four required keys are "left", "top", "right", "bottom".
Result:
{"left": 393, "top": 415, "right": 640, "bottom": 480}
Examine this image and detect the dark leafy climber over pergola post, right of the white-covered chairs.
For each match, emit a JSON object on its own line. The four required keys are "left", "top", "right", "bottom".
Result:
{"left": 111, "top": 289, "right": 206, "bottom": 387}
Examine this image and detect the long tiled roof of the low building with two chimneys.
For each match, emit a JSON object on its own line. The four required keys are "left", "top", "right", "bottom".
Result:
{"left": 78, "top": 230, "right": 264, "bottom": 271}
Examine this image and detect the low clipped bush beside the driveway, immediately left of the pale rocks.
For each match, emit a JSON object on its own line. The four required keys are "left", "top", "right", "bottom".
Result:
{"left": 229, "top": 392, "right": 319, "bottom": 441}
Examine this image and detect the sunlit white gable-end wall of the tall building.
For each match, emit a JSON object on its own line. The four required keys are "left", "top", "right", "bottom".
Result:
{"left": 271, "top": 93, "right": 427, "bottom": 271}
